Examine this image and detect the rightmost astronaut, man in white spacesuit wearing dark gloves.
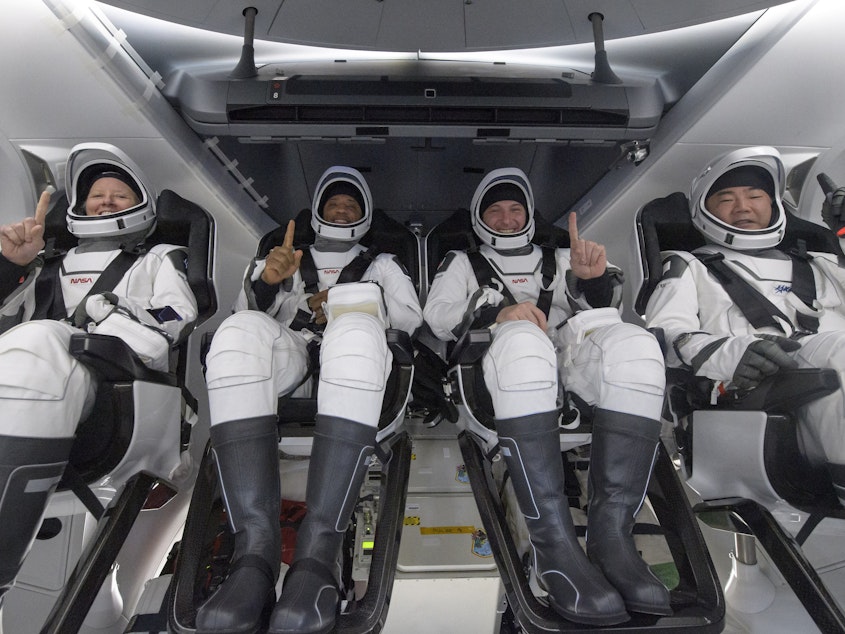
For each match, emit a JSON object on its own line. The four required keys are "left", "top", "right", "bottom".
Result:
{"left": 646, "top": 147, "right": 845, "bottom": 503}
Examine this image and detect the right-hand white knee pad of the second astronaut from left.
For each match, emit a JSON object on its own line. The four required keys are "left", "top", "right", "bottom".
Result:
{"left": 320, "top": 313, "right": 393, "bottom": 392}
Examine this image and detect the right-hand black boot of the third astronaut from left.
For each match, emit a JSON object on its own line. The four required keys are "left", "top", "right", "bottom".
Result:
{"left": 587, "top": 409, "right": 672, "bottom": 615}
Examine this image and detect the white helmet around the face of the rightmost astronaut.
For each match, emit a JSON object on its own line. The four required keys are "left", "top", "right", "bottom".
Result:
{"left": 689, "top": 146, "right": 786, "bottom": 251}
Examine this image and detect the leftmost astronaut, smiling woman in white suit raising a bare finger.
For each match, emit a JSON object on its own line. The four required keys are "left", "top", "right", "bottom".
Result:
{"left": 0, "top": 143, "right": 197, "bottom": 601}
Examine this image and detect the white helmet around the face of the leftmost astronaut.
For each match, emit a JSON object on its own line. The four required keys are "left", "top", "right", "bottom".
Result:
{"left": 65, "top": 143, "right": 156, "bottom": 238}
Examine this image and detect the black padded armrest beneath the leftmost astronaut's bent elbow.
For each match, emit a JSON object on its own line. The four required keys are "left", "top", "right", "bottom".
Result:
{"left": 68, "top": 333, "right": 178, "bottom": 387}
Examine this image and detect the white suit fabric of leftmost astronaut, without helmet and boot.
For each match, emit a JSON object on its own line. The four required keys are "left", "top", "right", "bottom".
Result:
{"left": 0, "top": 245, "right": 197, "bottom": 437}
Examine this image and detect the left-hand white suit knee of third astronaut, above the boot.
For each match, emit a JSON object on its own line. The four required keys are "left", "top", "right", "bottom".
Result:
{"left": 482, "top": 321, "right": 558, "bottom": 418}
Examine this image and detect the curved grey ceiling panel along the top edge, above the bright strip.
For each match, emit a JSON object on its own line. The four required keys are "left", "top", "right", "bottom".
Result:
{"left": 95, "top": 0, "right": 790, "bottom": 52}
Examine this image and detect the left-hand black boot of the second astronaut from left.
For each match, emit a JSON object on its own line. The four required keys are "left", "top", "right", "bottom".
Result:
{"left": 196, "top": 416, "right": 282, "bottom": 634}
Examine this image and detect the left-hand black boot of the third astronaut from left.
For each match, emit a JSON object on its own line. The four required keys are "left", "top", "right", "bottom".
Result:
{"left": 496, "top": 411, "right": 629, "bottom": 625}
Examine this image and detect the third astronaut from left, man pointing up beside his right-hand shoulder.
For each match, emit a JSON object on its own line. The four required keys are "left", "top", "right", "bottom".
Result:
{"left": 424, "top": 168, "right": 671, "bottom": 625}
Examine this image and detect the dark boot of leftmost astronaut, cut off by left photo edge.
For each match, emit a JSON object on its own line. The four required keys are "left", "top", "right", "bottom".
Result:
{"left": 0, "top": 436, "right": 73, "bottom": 594}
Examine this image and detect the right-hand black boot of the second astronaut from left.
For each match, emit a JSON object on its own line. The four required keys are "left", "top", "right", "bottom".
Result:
{"left": 269, "top": 414, "right": 376, "bottom": 634}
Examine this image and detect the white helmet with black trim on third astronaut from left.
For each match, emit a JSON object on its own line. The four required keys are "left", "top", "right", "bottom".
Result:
{"left": 470, "top": 167, "right": 534, "bottom": 250}
